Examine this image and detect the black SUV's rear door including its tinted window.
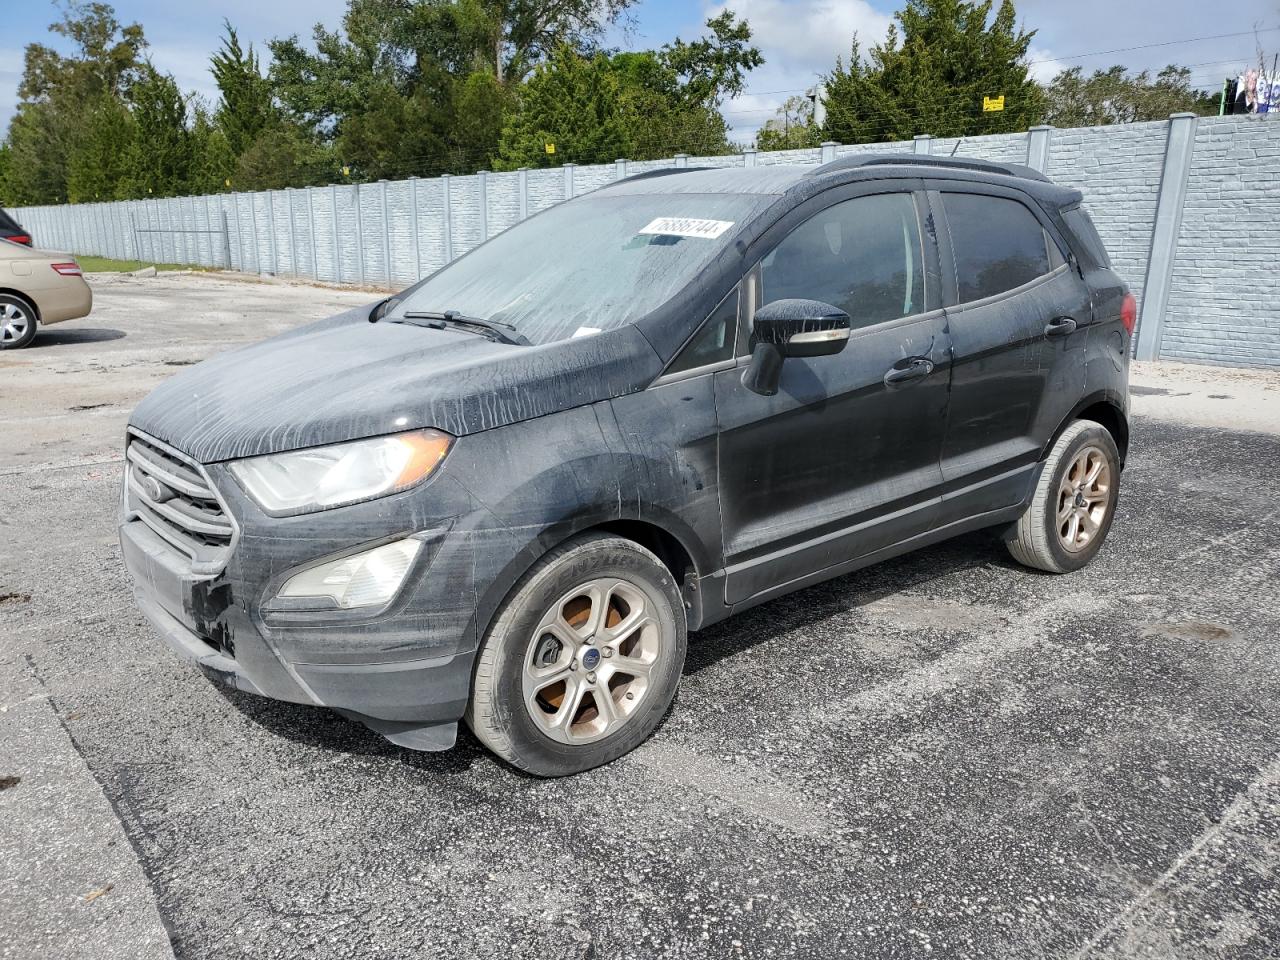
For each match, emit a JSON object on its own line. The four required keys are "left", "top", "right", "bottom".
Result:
{"left": 929, "top": 182, "right": 1092, "bottom": 520}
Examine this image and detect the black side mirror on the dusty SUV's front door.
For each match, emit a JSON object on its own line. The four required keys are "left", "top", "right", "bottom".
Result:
{"left": 742, "top": 300, "right": 849, "bottom": 397}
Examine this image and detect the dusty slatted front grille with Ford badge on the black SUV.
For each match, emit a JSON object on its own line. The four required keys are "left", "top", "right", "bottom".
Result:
{"left": 124, "top": 433, "right": 236, "bottom": 575}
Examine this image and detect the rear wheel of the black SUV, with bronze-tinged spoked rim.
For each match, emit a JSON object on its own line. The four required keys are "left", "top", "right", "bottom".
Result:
{"left": 1007, "top": 420, "right": 1120, "bottom": 573}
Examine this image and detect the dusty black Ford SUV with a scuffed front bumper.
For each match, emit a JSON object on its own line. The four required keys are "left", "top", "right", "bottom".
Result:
{"left": 120, "top": 156, "right": 1135, "bottom": 776}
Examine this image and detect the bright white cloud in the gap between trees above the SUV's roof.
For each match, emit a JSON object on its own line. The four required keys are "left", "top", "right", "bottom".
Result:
{"left": 704, "top": 0, "right": 892, "bottom": 142}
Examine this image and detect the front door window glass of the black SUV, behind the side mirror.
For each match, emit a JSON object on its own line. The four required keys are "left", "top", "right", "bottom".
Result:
{"left": 760, "top": 193, "right": 924, "bottom": 329}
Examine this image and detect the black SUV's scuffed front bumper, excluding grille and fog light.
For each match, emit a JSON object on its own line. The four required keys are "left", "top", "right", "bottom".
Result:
{"left": 120, "top": 442, "right": 476, "bottom": 750}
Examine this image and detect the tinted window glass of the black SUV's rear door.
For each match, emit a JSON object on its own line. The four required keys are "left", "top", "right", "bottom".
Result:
{"left": 942, "top": 193, "right": 1050, "bottom": 303}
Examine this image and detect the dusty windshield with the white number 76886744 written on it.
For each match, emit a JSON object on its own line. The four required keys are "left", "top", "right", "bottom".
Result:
{"left": 388, "top": 193, "right": 776, "bottom": 343}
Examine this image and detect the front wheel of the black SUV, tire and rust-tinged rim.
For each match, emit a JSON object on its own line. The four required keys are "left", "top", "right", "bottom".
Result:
{"left": 466, "top": 534, "right": 687, "bottom": 777}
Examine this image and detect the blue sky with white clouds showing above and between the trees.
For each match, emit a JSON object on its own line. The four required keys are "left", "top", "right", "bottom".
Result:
{"left": 0, "top": 0, "right": 1280, "bottom": 141}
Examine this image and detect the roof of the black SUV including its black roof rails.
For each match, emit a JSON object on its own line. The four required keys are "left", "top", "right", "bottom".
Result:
{"left": 602, "top": 154, "right": 1079, "bottom": 206}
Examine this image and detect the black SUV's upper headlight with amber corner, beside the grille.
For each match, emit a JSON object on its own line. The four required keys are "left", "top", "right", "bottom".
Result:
{"left": 230, "top": 430, "right": 453, "bottom": 515}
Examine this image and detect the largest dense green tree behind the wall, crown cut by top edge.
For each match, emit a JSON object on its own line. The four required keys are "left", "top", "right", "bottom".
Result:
{"left": 270, "top": 0, "right": 634, "bottom": 178}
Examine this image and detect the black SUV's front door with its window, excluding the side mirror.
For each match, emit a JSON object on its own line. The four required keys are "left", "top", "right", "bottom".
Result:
{"left": 716, "top": 183, "right": 950, "bottom": 604}
